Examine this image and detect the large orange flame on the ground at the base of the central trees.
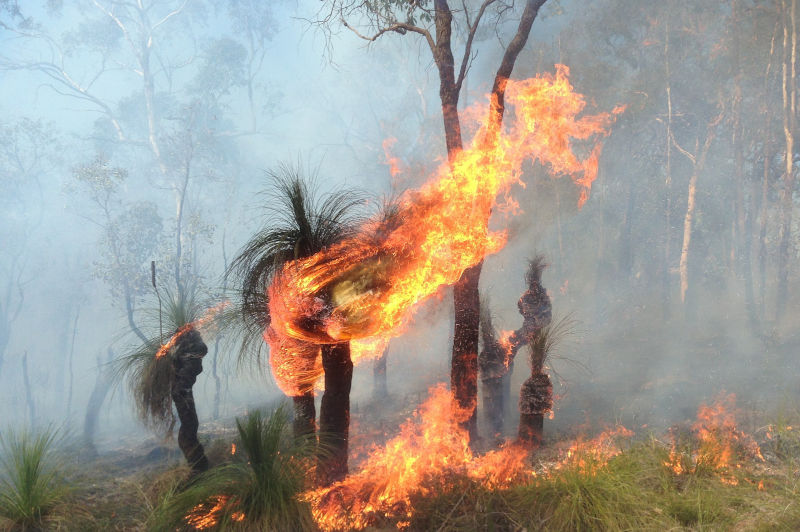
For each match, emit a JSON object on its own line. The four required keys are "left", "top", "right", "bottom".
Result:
{"left": 303, "top": 384, "right": 527, "bottom": 530}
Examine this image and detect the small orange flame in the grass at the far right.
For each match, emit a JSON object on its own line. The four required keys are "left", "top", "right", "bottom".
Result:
{"left": 664, "top": 394, "right": 764, "bottom": 478}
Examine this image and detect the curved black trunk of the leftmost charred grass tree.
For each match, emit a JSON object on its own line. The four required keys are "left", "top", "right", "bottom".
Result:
{"left": 172, "top": 329, "right": 208, "bottom": 475}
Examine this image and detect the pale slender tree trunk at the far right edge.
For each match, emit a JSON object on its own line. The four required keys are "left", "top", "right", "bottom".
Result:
{"left": 775, "top": 0, "right": 797, "bottom": 321}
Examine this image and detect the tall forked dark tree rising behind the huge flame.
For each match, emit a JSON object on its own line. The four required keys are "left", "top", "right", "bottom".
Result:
{"left": 318, "top": 0, "right": 546, "bottom": 440}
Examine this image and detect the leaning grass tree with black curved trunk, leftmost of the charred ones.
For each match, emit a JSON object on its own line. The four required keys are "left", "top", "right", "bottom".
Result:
{"left": 116, "top": 290, "right": 208, "bottom": 475}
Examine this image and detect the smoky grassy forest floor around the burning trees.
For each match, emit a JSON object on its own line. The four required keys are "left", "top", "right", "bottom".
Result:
{"left": 9, "top": 306, "right": 800, "bottom": 531}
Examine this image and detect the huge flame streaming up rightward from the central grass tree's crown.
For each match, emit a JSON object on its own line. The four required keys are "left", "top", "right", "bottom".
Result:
{"left": 265, "top": 65, "right": 623, "bottom": 395}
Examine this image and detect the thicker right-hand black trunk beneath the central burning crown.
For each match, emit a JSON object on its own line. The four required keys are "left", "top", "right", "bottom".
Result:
{"left": 319, "top": 343, "right": 353, "bottom": 485}
